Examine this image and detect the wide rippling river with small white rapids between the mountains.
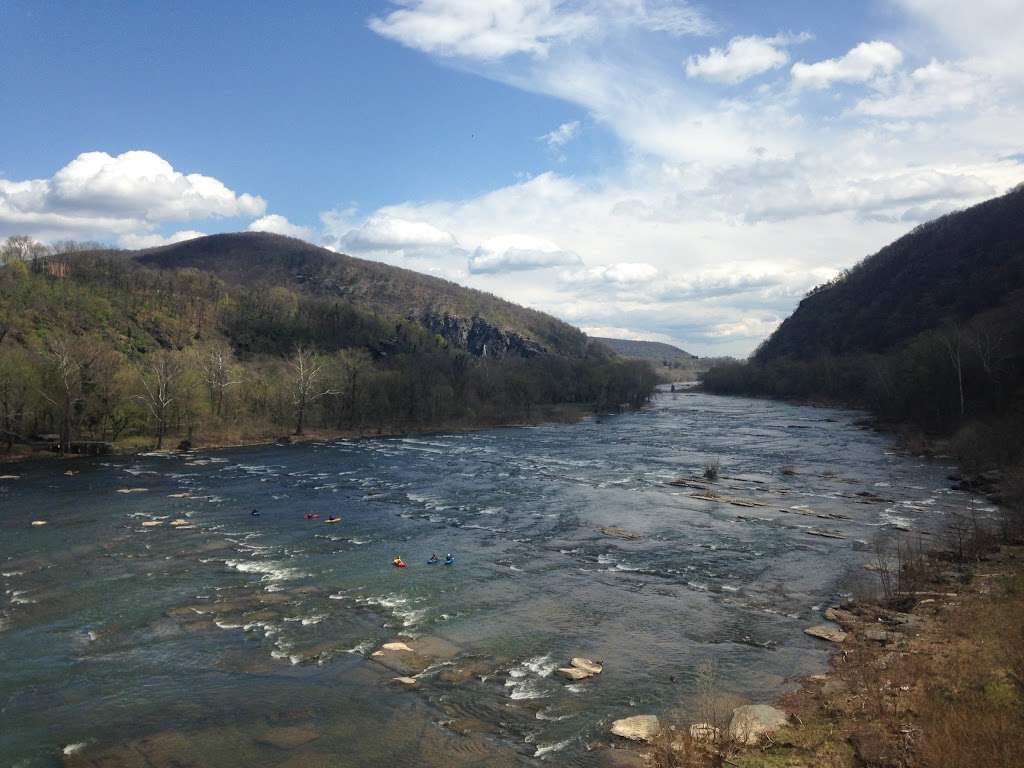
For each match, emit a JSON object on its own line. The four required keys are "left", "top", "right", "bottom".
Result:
{"left": 0, "top": 393, "right": 981, "bottom": 768}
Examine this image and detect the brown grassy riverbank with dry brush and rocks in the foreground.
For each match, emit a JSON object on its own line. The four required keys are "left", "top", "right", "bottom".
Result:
{"left": 609, "top": 546, "right": 1024, "bottom": 768}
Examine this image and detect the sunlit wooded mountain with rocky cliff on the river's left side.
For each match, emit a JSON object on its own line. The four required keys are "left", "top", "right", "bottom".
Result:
{"left": 0, "top": 233, "right": 654, "bottom": 452}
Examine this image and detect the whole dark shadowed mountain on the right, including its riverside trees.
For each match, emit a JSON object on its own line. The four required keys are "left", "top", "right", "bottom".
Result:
{"left": 703, "top": 186, "right": 1024, "bottom": 475}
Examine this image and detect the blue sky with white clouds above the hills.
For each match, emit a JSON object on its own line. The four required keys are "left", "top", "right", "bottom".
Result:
{"left": 0, "top": 0, "right": 1024, "bottom": 354}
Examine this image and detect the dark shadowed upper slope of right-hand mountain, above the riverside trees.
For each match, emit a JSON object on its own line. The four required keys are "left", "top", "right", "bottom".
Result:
{"left": 755, "top": 185, "right": 1024, "bottom": 362}
